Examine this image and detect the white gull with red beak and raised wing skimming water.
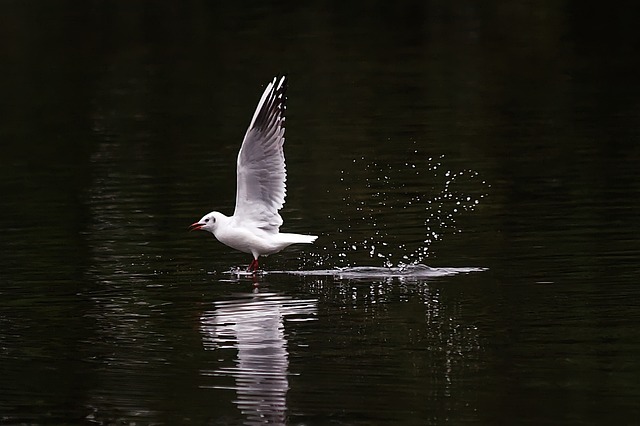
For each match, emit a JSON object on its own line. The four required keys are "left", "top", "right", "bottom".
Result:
{"left": 189, "top": 76, "right": 318, "bottom": 272}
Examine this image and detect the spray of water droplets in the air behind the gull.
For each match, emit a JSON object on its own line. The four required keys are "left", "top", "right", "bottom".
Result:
{"left": 309, "top": 149, "right": 490, "bottom": 270}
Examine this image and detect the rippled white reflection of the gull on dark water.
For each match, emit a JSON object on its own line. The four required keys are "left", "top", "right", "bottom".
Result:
{"left": 201, "top": 293, "right": 317, "bottom": 424}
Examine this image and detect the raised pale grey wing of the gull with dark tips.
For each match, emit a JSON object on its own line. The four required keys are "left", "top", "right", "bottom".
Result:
{"left": 233, "top": 76, "right": 287, "bottom": 232}
